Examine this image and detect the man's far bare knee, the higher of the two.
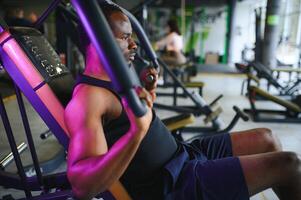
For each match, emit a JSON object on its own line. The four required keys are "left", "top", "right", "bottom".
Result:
{"left": 256, "top": 128, "right": 282, "bottom": 152}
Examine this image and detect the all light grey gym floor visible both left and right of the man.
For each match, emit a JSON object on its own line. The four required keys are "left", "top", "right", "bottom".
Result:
{"left": 0, "top": 73, "right": 301, "bottom": 200}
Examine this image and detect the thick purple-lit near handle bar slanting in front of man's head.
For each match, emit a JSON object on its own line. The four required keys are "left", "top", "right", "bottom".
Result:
{"left": 71, "top": 0, "right": 146, "bottom": 117}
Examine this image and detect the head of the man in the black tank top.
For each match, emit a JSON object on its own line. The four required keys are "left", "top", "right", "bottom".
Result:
{"left": 80, "top": 5, "right": 137, "bottom": 63}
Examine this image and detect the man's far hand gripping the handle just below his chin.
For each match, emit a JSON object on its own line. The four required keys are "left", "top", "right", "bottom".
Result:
{"left": 139, "top": 67, "right": 158, "bottom": 102}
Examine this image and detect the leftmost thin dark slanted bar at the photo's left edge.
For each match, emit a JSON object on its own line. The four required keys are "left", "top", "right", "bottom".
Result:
{"left": 0, "top": 94, "right": 32, "bottom": 198}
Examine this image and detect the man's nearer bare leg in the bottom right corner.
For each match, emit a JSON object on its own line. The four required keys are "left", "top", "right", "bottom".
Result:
{"left": 239, "top": 152, "right": 301, "bottom": 200}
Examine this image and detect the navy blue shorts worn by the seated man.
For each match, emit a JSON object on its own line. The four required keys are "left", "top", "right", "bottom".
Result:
{"left": 163, "top": 134, "right": 249, "bottom": 200}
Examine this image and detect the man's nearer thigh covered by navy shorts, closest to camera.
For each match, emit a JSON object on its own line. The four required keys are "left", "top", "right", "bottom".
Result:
{"left": 167, "top": 157, "right": 249, "bottom": 200}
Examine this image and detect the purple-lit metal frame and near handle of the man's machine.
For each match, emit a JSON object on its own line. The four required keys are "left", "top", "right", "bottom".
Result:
{"left": 0, "top": 0, "right": 162, "bottom": 200}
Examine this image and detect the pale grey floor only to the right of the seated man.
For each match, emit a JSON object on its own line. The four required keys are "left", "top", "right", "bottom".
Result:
{"left": 158, "top": 73, "right": 301, "bottom": 200}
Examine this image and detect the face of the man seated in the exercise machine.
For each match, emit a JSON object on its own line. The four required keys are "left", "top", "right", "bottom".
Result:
{"left": 109, "top": 12, "right": 137, "bottom": 64}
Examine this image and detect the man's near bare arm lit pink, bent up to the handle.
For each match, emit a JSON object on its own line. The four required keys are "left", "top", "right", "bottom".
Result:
{"left": 65, "top": 88, "right": 151, "bottom": 199}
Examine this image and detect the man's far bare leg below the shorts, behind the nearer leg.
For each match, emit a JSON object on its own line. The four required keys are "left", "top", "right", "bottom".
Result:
{"left": 230, "top": 128, "right": 282, "bottom": 156}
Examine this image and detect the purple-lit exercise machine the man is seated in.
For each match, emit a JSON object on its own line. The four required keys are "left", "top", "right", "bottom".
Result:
{"left": 0, "top": 0, "right": 197, "bottom": 200}
